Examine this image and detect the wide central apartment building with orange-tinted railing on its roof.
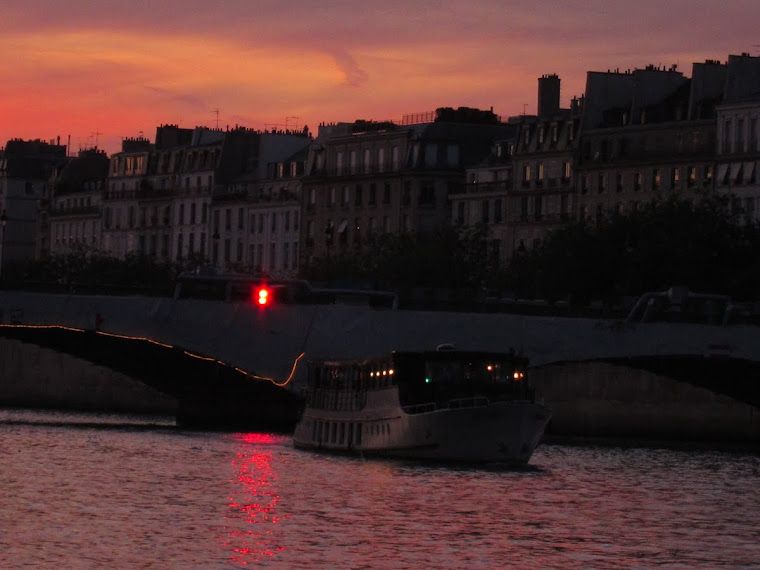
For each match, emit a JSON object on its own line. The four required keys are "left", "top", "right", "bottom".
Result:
{"left": 301, "top": 108, "right": 513, "bottom": 262}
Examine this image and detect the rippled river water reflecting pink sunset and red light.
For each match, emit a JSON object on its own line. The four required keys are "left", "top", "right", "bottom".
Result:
{"left": 0, "top": 410, "right": 760, "bottom": 568}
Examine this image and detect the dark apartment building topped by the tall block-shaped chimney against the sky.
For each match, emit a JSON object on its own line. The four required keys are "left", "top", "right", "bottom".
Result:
{"left": 451, "top": 74, "right": 582, "bottom": 258}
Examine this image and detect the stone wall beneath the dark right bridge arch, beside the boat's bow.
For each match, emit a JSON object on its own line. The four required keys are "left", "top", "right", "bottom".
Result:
{"left": 530, "top": 362, "right": 760, "bottom": 445}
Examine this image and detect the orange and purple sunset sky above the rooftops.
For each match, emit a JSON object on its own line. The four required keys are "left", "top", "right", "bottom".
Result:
{"left": 0, "top": 0, "right": 760, "bottom": 153}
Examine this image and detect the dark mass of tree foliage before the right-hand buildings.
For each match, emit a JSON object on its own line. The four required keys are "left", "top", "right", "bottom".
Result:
{"left": 507, "top": 196, "right": 760, "bottom": 303}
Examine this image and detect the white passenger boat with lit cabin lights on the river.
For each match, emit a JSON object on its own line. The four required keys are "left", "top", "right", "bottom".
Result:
{"left": 293, "top": 346, "right": 551, "bottom": 465}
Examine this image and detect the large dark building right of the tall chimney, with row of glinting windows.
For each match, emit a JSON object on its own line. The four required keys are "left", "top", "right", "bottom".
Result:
{"left": 575, "top": 61, "right": 725, "bottom": 221}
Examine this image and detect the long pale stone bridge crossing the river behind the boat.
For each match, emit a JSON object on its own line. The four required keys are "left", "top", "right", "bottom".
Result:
{"left": 0, "top": 292, "right": 760, "bottom": 442}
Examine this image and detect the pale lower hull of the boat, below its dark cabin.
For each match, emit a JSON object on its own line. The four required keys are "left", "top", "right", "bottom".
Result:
{"left": 293, "top": 401, "right": 551, "bottom": 465}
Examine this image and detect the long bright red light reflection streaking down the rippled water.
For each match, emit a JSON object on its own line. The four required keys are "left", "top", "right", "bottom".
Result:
{"left": 218, "top": 433, "right": 287, "bottom": 566}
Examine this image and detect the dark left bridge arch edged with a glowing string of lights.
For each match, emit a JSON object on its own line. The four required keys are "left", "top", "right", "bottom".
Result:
{"left": 0, "top": 325, "right": 302, "bottom": 431}
